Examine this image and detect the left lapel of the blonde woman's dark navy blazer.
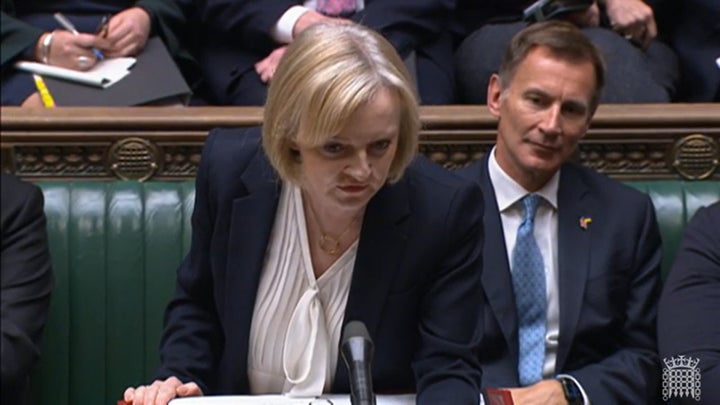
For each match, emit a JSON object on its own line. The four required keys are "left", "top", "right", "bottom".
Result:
{"left": 226, "top": 150, "right": 280, "bottom": 388}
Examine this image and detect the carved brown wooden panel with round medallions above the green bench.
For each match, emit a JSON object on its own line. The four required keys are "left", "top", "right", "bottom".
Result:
{"left": 0, "top": 104, "right": 720, "bottom": 181}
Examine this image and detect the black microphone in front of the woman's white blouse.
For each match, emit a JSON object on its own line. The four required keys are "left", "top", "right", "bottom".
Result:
{"left": 340, "top": 321, "right": 375, "bottom": 405}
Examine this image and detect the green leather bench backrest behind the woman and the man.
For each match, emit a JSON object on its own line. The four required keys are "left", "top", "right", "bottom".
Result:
{"left": 31, "top": 181, "right": 720, "bottom": 405}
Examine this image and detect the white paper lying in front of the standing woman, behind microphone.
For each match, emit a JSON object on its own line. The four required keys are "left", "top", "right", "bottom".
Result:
{"left": 170, "top": 394, "right": 415, "bottom": 405}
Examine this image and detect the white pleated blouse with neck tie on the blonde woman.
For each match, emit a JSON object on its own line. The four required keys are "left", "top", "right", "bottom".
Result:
{"left": 249, "top": 184, "right": 358, "bottom": 397}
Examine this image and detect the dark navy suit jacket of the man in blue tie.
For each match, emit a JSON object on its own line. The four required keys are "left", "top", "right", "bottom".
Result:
{"left": 461, "top": 154, "right": 661, "bottom": 404}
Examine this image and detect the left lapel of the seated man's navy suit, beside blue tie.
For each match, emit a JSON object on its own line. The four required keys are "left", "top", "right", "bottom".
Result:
{"left": 480, "top": 153, "right": 518, "bottom": 355}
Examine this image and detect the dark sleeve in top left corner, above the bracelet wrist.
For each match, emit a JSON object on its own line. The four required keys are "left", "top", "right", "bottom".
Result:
{"left": 0, "top": 0, "right": 43, "bottom": 70}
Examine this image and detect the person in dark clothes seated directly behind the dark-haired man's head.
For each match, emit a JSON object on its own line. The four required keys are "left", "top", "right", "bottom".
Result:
{"left": 455, "top": 0, "right": 680, "bottom": 104}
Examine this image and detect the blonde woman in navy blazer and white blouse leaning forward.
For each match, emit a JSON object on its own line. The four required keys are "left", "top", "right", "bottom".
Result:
{"left": 124, "top": 24, "right": 483, "bottom": 405}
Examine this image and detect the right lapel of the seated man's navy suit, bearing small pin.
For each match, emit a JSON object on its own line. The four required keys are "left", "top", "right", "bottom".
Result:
{"left": 555, "top": 165, "right": 598, "bottom": 372}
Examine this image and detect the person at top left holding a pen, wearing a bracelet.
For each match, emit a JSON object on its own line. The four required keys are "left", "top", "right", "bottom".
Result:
{"left": 2, "top": 0, "right": 199, "bottom": 106}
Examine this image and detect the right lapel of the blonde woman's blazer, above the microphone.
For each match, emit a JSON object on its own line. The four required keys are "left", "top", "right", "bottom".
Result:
{"left": 333, "top": 181, "right": 410, "bottom": 390}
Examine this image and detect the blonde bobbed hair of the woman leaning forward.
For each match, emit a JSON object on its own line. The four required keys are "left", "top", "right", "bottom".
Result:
{"left": 262, "top": 24, "right": 420, "bottom": 183}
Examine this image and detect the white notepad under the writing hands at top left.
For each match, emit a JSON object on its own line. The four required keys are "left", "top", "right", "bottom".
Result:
{"left": 15, "top": 57, "right": 136, "bottom": 89}
